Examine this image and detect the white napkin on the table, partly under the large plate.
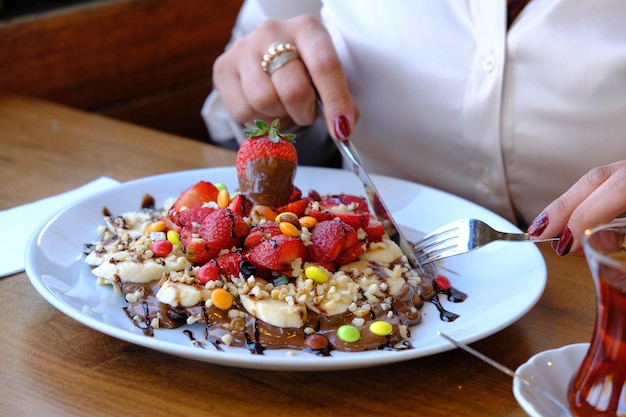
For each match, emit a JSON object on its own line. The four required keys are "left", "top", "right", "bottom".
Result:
{"left": 0, "top": 177, "right": 119, "bottom": 277}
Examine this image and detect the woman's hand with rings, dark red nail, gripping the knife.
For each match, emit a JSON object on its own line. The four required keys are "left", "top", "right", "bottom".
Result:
{"left": 213, "top": 15, "right": 358, "bottom": 137}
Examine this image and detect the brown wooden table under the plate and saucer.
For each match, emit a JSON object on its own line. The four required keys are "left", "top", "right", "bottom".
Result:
{"left": 0, "top": 95, "right": 595, "bottom": 417}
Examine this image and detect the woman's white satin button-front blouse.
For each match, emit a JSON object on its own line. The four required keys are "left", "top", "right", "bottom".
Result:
{"left": 202, "top": 0, "right": 626, "bottom": 222}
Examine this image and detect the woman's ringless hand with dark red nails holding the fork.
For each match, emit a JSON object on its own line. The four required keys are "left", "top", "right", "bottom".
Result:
{"left": 528, "top": 160, "right": 626, "bottom": 256}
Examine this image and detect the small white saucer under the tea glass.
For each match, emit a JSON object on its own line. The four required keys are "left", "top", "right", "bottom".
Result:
{"left": 513, "top": 343, "right": 589, "bottom": 417}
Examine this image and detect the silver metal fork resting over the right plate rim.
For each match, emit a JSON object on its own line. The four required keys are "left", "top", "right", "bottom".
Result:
{"left": 413, "top": 219, "right": 559, "bottom": 265}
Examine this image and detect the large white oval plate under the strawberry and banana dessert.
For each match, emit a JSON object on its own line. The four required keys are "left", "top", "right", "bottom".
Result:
{"left": 26, "top": 167, "right": 546, "bottom": 371}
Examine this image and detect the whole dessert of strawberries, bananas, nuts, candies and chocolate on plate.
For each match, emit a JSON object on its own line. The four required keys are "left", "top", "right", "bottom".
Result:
{"left": 85, "top": 118, "right": 465, "bottom": 355}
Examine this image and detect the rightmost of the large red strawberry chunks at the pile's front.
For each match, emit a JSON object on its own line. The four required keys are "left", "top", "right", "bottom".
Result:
{"left": 309, "top": 219, "right": 361, "bottom": 263}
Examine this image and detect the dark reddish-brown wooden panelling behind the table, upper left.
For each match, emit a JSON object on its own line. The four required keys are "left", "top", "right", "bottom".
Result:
{"left": 0, "top": 0, "right": 242, "bottom": 140}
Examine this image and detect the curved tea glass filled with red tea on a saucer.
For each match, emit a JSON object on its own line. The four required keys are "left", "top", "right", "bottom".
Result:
{"left": 568, "top": 220, "right": 626, "bottom": 417}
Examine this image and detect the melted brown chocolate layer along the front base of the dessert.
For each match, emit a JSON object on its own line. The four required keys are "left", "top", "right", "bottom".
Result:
{"left": 120, "top": 272, "right": 458, "bottom": 356}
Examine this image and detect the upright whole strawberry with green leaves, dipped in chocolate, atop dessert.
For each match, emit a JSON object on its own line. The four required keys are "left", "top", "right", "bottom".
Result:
{"left": 237, "top": 119, "right": 298, "bottom": 208}
